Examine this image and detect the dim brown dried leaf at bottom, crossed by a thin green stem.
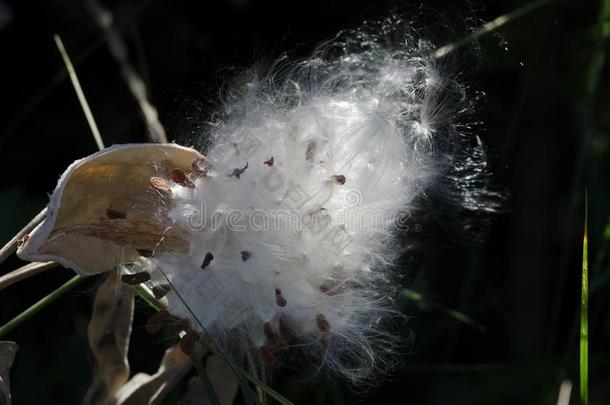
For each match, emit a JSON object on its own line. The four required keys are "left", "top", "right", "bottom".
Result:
{"left": 180, "top": 355, "right": 239, "bottom": 405}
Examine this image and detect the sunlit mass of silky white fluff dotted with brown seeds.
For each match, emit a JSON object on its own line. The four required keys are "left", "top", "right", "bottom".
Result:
{"left": 139, "top": 22, "right": 494, "bottom": 380}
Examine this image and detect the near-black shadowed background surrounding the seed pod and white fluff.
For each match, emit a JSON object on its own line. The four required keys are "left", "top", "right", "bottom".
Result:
{"left": 0, "top": 0, "right": 610, "bottom": 405}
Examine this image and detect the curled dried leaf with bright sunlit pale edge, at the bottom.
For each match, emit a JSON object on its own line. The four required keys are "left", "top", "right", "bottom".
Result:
{"left": 116, "top": 346, "right": 192, "bottom": 405}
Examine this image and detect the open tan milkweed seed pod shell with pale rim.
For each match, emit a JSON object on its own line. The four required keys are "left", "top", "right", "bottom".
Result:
{"left": 17, "top": 144, "right": 202, "bottom": 275}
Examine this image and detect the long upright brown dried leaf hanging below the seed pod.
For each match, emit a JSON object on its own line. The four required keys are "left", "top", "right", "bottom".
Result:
{"left": 83, "top": 272, "right": 134, "bottom": 405}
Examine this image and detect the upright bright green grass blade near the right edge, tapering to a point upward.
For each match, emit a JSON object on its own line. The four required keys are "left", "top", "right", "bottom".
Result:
{"left": 580, "top": 191, "right": 589, "bottom": 405}
